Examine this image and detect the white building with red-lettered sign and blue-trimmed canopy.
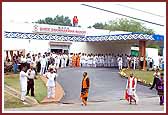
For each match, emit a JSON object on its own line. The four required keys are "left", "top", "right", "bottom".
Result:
{"left": 2, "top": 22, "right": 164, "bottom": 69}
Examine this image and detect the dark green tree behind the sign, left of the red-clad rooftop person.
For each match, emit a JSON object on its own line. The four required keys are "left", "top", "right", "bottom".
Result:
{"left": 35, "top": 15, "right": 72, "bottom": 26}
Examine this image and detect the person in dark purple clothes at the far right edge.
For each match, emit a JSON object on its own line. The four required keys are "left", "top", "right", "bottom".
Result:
{"left": 157, "top": 73, "right": 164, "bottom": 105}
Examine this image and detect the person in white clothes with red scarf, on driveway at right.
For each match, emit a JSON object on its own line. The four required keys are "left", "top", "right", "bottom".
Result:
{"left": 126, "top": 73, "right": 139, "bottom": 104}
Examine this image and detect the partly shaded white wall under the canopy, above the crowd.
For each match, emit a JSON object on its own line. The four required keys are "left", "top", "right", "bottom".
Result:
{"left": 70, "top": 41, "right": 132, "bottom": 54}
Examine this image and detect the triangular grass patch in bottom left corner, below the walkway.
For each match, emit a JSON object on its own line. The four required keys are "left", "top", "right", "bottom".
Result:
{"left": 4, "top": 92, "right": 28, "bottom": 108}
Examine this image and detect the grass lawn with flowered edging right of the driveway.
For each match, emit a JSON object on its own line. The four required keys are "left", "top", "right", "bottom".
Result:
{"left": 124, "top": 69, "right": 164, "bottom": 83}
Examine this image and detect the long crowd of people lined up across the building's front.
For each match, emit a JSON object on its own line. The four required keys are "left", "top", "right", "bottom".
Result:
{"left": 5, "top": 52, "right": 163, "bottom": 75}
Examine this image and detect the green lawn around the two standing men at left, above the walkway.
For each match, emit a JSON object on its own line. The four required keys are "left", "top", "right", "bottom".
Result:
{"left": 4, "top": 74, "right": 47, "bottom": 103}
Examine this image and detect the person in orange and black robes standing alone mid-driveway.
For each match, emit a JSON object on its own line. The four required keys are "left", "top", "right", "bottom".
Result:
{"left": 80, "top": 72, "right": 90, "bottom": 106}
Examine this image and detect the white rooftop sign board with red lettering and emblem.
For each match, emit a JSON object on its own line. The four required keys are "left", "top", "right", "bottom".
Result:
{"left": 33, "top": 24, "right": 86, "bottom": 36}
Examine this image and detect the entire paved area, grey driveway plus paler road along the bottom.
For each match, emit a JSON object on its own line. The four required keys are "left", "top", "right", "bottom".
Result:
{"left": 5, "top": 68, "right": 164, "bottom": 112}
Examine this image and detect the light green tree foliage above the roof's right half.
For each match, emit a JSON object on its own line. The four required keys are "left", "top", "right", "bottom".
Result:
{"left": 93, "top": 18, "right": 154, "bottom": 34}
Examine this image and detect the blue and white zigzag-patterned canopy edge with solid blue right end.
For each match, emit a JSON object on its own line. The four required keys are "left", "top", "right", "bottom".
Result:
{"left": 4, "top": 31, "right": 164, "bottom": 42}
